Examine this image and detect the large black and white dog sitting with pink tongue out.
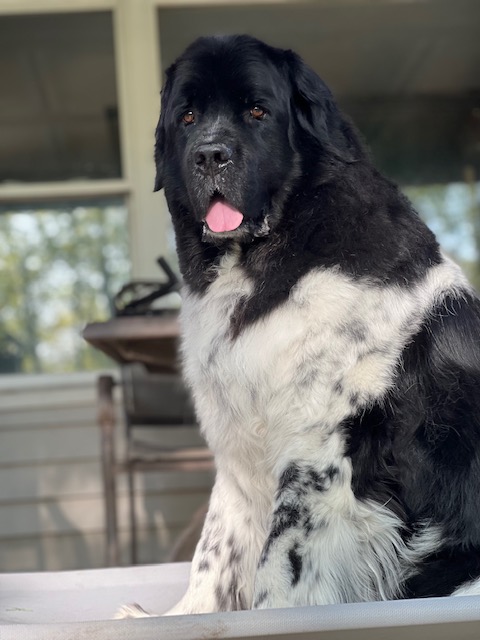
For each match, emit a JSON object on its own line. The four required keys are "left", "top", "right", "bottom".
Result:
{"left": 139, "top": 36, "right": 480, "bottom": 614}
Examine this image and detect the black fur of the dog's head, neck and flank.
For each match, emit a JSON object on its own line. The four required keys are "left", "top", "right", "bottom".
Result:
{"left": 155, "top": 36, "right": 480, "bottom": 604}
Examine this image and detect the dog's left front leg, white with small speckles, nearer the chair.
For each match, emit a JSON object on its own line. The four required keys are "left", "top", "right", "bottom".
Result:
{"left": 163, "top": 470, "right": 265, "bottom": 615}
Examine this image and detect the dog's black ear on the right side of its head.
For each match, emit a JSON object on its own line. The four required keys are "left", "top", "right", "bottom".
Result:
{"left": 286, "top": 51, "right": 362, "bottom": 162}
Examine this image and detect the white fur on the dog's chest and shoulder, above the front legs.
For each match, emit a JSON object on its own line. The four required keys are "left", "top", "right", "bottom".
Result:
{"left": 181, "top": 254, "right": 464, "bottom": 477}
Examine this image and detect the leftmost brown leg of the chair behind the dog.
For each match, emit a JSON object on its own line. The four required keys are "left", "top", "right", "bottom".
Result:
{"left": 97, "top": 376, "right": 120, "bottom": 567}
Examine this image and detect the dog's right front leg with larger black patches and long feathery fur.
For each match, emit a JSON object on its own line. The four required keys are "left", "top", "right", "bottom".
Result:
{"left": 253, "top": 458, "right": 407, "bottom": 608}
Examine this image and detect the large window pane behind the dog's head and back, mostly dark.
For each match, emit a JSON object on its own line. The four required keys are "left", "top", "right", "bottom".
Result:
{"left": 159, "top": 0, "right": 480, "bottom": 288}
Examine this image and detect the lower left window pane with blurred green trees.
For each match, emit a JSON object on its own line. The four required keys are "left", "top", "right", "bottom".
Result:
{"left": 0, "top": 200, "right": 130, "bottom": 373}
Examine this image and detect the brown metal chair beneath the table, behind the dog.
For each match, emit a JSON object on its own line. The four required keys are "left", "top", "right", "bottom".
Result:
{"left": 98, "top": 362, "right": 213, "bottom": 566}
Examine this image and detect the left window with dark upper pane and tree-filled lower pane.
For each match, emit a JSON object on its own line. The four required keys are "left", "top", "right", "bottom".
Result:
{"left": 0, "top": 11, "right": 130, "bottom": 374}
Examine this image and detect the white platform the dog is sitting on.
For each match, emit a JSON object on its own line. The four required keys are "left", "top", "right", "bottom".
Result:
{"left": 0, "top": 564, "right": 480, "bottom": 640}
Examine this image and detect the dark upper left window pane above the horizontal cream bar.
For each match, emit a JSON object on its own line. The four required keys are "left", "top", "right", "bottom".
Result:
{"left": 0, "top": 12, "right": 121, "bottom": 183}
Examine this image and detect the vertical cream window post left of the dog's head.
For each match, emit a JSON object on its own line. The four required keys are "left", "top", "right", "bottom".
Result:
{"left": 114, "top": 0, "right": 168, "bottom": 277}
